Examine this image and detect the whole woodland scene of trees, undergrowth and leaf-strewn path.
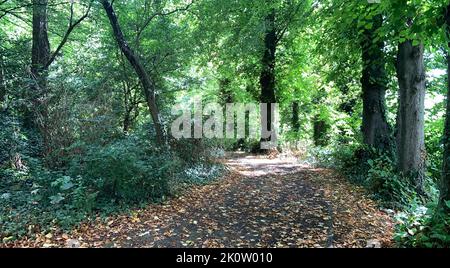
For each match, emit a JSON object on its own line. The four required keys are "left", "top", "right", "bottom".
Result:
{"left": 0, "top": 0, "right": 450, "bottom": 248}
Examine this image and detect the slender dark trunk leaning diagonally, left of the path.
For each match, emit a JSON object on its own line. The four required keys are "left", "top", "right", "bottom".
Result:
{"left": 102, "top": 0, "right": 167, "bottom": 145}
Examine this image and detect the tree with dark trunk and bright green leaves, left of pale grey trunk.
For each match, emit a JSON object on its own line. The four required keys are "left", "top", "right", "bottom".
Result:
{"left": 317, "top": 1, "right": 393, "bottom": 151}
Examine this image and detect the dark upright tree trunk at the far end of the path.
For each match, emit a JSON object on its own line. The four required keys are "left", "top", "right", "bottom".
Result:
{"left": 260, "top": 11, "right": 277, "bottom": 148}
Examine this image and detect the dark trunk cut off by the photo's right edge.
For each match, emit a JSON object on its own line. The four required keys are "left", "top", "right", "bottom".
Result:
{"left": 439, "top": 5, "right": 450, "bottom": 212}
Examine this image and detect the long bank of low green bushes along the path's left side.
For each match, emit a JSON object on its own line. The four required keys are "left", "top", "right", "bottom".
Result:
{"left": 0, "top": 131, "right": 223, "bottom": 241}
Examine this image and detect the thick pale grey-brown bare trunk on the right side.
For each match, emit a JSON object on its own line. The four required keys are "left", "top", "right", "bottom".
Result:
{"left": 397, "top": 40, "right": 426, "bottom": 194}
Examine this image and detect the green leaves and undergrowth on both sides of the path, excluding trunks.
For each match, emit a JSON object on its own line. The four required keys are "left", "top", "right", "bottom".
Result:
{"left": 0, "top": 0, "right": 448, "bottom": 247}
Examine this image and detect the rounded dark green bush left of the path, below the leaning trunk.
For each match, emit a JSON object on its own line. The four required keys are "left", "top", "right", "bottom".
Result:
{"left": 68, "top": 137, "right": 180, "bottom": 203}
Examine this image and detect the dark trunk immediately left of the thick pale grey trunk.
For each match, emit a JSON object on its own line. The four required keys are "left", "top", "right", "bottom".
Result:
{"left": 361, "top": 15, "right": 392, "bottom": 151}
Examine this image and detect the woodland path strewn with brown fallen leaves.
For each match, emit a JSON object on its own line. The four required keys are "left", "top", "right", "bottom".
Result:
{"left": 9, "top": 154, "right": 393, "bottom": 248}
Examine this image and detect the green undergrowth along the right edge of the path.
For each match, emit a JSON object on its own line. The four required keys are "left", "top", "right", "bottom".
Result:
{"left": 308, "top": 145, "right": 450, "bottom": 248}
